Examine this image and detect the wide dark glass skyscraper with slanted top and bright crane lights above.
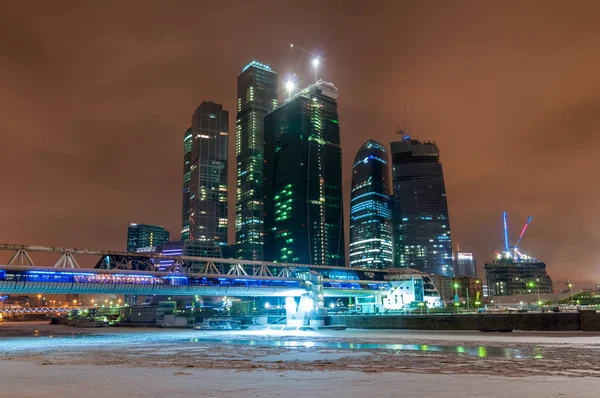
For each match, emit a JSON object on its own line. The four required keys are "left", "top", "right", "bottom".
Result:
{"left": 264, "top": 81, "right": 345, "bottom": 266}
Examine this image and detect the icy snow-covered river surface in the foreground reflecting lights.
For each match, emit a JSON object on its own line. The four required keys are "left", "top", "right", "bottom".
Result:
{"left": 0, "top": 323, "right": 600, "bottom": 398}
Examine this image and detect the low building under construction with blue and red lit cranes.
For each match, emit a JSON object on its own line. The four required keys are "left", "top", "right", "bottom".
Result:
{"left": 484, "top": 212, "right": 552, "bottom": 296}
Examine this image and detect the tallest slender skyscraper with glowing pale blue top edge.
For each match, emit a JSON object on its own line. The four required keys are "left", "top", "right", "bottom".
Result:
{"left": 234, "top": 61, "right": 277, "bottom": 260}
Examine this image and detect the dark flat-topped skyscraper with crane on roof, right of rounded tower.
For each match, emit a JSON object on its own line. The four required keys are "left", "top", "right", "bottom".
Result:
{"left": 391, "top": 137, "right": 454, "bottom": 277}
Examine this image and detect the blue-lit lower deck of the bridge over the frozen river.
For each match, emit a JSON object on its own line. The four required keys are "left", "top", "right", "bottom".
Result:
{"left": 0, "top": 266, "right": 391, "bottom": 297}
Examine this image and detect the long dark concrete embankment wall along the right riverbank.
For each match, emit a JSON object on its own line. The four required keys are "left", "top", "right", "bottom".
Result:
{"left": 326, "top": 311, "right": 600, "bottom": 332}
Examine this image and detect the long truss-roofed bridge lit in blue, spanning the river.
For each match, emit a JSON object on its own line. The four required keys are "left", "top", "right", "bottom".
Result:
{"left": 0, "top": 244, "right": 439, "bottom": 310}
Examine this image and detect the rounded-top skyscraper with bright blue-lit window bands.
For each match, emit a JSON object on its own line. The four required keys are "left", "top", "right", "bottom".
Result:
{"left": 350, "top": 140, "right": 393, "bottom": 269}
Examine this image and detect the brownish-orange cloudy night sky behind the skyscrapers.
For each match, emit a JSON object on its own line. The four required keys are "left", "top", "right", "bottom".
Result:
{"left": 0, "top": 0, "right": 600, "bottom": 280}
